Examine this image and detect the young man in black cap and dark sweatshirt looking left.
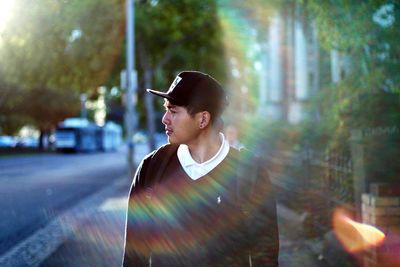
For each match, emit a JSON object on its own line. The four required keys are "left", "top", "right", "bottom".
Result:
{"left": 123, "top": 71, "right": 279, "bottom": 267}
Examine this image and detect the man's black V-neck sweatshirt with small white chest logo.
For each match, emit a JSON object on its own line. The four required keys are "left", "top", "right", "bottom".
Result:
{"left": 123, "top": 145, "right": 279, "bottom": 267}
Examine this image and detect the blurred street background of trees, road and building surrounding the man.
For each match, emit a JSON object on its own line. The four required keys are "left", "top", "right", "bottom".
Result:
{"left": 0, "top": 0, "right": 400, "bottom": 267}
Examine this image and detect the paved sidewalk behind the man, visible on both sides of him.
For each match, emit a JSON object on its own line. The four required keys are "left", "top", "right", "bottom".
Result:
{"left": 39, "top": 179, "right": 327, "bottom": 267}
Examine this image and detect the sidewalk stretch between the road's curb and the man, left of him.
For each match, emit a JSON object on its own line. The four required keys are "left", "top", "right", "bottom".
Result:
{"left": 39, "top": 179, "right": 130, "bottom": 267}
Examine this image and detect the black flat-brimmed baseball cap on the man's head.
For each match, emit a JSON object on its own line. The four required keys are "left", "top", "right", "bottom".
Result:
{"left": 147, "top": 71, "right": 228, "bottom": 115}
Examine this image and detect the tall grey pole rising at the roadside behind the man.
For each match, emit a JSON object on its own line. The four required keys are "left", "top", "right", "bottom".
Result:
{"left": 125, "top": 0, "right": 137, "bottom": 177}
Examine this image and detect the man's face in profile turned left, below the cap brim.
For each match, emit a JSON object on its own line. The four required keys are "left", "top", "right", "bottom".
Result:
{"left": 162, "top": 100, "right": 200, "bottom": 144}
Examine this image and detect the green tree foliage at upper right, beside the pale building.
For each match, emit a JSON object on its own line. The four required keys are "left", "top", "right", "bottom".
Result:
{"left": 299, "top": 0, "right": 400, "bottom": 147}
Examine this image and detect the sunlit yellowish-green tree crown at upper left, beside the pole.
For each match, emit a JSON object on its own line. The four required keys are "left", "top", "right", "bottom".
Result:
{"left": 0, "top": 0, "right": 124, "bottom": 144}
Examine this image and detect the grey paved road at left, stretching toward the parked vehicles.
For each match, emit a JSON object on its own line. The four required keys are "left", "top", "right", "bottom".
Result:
{"left": 0, "top": 151, "right": 126, "bottom": 254}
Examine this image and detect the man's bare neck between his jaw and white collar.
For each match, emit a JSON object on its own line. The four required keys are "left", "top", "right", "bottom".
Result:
{"left": 187, "top": 129, "right": 222, "bottom": 163}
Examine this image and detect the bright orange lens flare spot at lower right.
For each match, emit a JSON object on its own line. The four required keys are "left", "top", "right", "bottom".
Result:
{"left": 333, "top": 209, "right": 385, "bottom": 253}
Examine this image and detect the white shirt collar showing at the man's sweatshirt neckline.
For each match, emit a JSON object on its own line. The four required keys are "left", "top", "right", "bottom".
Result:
{"left": 177, "top": 133, "right": 229, "bottom": 180}
